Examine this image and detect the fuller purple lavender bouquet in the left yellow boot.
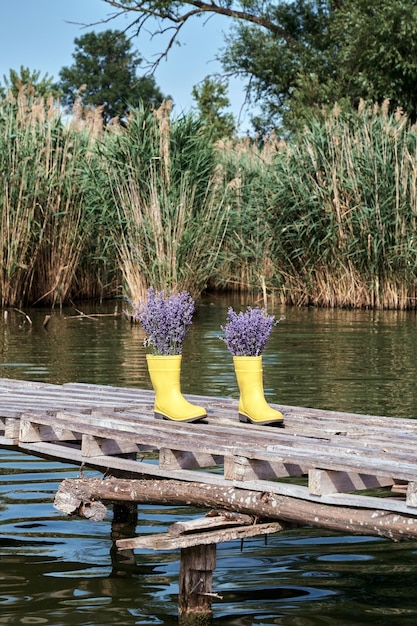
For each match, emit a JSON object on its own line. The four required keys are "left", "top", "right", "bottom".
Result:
{"left": 132, "top": 287, "right": 194, "bottom": 356}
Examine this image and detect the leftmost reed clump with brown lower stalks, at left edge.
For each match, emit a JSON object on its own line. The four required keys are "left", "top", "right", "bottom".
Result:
{"left": 0, "top": 91, "right": 97, "bottom": 306}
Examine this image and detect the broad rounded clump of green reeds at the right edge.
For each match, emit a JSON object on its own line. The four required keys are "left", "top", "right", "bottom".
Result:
{"left": 270, "top": 106, "right": 417, "bottom": 308}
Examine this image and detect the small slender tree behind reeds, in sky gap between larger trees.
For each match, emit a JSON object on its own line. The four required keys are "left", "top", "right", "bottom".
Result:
{"left": 192, "top": 77, "right": 235, "bottom": 139}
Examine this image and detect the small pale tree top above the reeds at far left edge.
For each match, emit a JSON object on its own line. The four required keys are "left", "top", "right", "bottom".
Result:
{"left": 0, "top": 65, "right": 61, "bottom": 99}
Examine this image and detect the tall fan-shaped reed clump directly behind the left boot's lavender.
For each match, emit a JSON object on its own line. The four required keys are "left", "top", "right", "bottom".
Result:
{"left": 107, "top": 103, "right": 227, "bottom": 300}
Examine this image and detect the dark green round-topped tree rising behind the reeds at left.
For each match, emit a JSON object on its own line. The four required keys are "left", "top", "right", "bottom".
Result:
{"left": 58, "top": 30, "right": 164, "bottom": 123}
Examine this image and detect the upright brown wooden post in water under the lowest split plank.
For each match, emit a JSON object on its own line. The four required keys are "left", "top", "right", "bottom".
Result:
{"left": 178, "top": 543, "right": 216, "bottom": 626}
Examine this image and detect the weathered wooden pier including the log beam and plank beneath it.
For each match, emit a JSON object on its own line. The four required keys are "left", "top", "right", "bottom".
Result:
{"left": 0, "top": 379, "right": 417, "bottom": 620}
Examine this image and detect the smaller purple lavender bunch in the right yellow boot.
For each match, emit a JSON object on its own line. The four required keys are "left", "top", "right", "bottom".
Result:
{"left": 221, "top": 306, "right": 278, "bottom": 356}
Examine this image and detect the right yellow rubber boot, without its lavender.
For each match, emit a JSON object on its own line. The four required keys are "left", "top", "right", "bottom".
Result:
{"left": 233, "top": 356, "right": 284, "bottom": 426}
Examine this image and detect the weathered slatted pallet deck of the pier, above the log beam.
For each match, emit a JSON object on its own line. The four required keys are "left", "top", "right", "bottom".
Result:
{"left": 0, "top": 379, "right": 417, "bottom": 540}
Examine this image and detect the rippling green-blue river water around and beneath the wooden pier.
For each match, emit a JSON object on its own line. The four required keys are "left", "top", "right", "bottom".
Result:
{"left": 0, "top": 297, "right": 417, "bottom": 626}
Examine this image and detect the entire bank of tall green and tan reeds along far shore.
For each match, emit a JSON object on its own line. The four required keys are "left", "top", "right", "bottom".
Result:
{"left": 0, "top": 93, "right": 417, "bottom": 309}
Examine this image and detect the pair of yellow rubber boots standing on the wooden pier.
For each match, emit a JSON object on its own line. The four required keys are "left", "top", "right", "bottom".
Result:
{"left": 146, "top": 354, "right": 284, "bottom": 426}
